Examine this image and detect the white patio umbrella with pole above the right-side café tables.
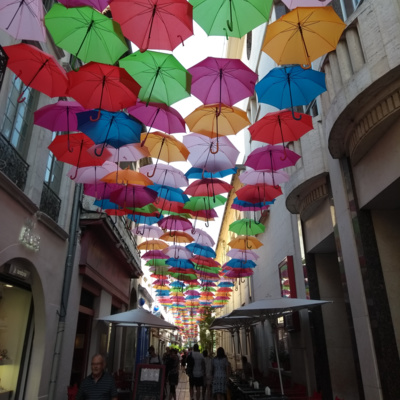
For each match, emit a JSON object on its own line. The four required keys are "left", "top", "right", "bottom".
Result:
{"left": 229, "top": 297, "right": 331, "bottom": 394}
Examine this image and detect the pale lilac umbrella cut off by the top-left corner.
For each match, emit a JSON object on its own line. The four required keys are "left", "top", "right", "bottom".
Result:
{"left": 0, "top": 0, "right": 46, "bottom": 42}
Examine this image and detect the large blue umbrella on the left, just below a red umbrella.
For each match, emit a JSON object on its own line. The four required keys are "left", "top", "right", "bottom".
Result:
{"left": 77, "top": 110, "right": 142, "bottom": 157}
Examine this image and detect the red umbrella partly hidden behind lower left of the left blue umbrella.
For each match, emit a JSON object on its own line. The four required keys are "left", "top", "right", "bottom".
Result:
{"left": 48, "top": 133, "right": 106, "bottom": 179}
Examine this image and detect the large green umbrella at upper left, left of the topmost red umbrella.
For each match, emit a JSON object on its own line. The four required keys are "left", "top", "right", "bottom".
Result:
{"left": 44, "top": 3, "right": 128, "bottom": 65}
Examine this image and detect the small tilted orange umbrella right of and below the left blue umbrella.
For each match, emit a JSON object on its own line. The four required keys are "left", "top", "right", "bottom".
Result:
{"left": 140, "top": 131, "right": 189, "bottom": 178}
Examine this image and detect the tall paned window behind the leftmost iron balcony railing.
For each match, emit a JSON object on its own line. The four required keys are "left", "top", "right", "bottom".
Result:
{"left": 1, "top": 78, "right": 36, "bottom": 157}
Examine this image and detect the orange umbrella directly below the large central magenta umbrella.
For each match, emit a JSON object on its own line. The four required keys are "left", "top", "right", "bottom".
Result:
{"left": 185, "top": 104, "right": 250, "bottom": 154}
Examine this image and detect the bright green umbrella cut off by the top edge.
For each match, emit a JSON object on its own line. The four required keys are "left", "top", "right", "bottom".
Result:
{"left": 189, "top": 0, "right": 272, "bottom": 38}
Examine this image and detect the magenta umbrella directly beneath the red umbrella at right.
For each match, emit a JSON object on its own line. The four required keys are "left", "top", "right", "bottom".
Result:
{"left": 244, "top": 145, "right": 300, "bottom": 171}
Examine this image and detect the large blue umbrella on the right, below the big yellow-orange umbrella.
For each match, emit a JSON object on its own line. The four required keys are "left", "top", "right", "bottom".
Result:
{"left": 255, "top": 65, "right": 326, "bottom": 119}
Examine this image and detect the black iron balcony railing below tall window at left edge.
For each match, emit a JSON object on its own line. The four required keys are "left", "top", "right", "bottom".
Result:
{"left": 0, "top": 133, "right": 29, "bottom": 190}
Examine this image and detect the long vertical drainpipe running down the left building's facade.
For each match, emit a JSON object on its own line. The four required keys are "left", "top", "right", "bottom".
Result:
{"left": 48, "top": 184, "right": 82, "bottom": 400}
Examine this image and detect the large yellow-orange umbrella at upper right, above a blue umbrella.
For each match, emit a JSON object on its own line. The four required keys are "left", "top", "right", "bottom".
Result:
{"left": 262, "top": 6, "right": 346, "bottom": 67}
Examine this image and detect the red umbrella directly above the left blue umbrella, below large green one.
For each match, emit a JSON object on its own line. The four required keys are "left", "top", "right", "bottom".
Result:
{"left": 68, "top": 62, "right": 140, "bottom": 119}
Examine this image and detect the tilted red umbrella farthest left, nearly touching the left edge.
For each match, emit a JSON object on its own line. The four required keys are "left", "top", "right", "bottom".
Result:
{"left": 3, "top": 43, "right": 68, "bottom": 103}
